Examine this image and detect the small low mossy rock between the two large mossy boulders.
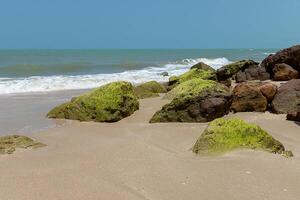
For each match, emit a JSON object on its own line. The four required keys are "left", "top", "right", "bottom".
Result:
{"left": 134, "top": 81, "right": 167, "bottom": 99}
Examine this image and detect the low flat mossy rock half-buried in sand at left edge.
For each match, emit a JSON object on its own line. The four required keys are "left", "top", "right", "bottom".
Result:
{"left": 0, "top": 135, "right": 45, "bottom": 154}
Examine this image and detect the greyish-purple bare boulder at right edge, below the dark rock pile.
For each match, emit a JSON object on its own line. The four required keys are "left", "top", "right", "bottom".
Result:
{"left": 272, "top": 79, "right": 300, "bottom": 114}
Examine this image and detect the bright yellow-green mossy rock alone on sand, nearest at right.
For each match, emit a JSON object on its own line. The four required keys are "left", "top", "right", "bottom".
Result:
{"left": 192, "top": 118, "right": 292, "bottom": 156}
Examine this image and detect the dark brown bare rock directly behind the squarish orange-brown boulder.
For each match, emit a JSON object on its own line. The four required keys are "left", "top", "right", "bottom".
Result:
{"left": 235, "top": 65, "right": 270, "bottom": 83}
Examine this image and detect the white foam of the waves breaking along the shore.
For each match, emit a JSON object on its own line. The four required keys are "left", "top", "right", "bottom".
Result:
{"left": 0, "top": 58, "right": 230, "bottom": 94}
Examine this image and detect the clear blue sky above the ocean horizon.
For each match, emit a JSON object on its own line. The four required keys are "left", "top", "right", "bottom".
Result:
{"left": 0, "top": 0, "right": 300, "bottom": 49}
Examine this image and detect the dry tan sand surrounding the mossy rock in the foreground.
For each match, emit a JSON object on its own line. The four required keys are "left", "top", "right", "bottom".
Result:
{"left": 0, "top": 98, "right": 300, "bottom": 200}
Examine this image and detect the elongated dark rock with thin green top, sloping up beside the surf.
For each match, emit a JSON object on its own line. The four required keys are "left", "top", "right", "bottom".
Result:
{"left": 217, "top": 60, "right": 258, "bottom": 81}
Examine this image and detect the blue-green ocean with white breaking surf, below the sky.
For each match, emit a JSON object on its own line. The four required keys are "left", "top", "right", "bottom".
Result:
{"left": 0, "top": 49, "right": 276, "bottom": 95}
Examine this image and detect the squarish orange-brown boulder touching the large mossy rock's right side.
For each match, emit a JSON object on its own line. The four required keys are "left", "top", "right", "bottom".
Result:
{"left": 231, "top": 82, "right": 268, "bottom": 112}
